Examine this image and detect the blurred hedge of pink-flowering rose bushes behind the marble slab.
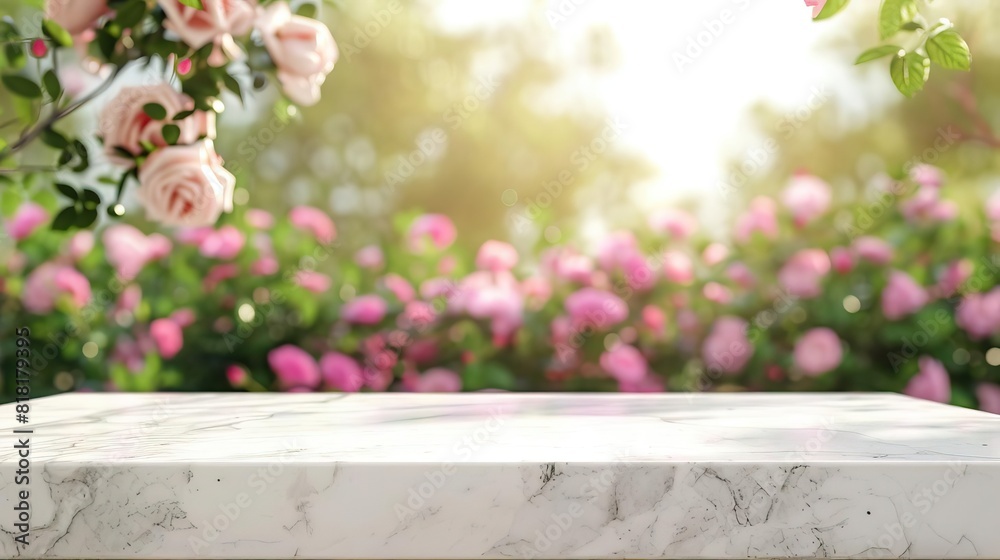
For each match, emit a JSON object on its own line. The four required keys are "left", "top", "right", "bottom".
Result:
{"left": 0, "top": 165, "right": 1000, "bottom": 413}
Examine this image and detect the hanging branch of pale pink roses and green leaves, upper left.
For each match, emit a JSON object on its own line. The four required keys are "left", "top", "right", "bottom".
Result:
{"left": 0, "top": 0, "right": 338, "bottom": 229}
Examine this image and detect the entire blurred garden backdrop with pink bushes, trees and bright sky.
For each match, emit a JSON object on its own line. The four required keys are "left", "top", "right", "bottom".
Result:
{"left": 0, "top": 0, "right": 1000, "bottom": 413}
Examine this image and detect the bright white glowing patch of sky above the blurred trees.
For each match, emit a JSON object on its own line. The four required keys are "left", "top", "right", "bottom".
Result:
{"left": 437, "top": 0, "right": 892, "bottom": 210}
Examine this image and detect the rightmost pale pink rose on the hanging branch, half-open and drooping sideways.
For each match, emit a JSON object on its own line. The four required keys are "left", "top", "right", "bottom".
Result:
{"left": 258, "top": 2, "right": 339, "bottom": 105}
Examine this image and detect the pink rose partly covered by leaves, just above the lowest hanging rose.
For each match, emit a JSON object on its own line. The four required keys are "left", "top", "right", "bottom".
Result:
{"left": 98, "top": 83, "right": 215, "bottom": 165}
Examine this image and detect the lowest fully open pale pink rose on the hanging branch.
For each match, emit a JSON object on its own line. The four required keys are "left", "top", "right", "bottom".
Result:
{"left": 136, "top": 141, "right": 236, "bottom": 227}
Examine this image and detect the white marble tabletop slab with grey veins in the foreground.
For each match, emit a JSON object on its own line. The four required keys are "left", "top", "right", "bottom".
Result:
{"left": 0, "top": 393, "right": 1000, "bottom": 559}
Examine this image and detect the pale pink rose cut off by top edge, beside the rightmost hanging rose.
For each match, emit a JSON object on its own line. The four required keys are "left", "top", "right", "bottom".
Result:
{"left": 158, "top": 0, "right": 256, "bottom": 49}
